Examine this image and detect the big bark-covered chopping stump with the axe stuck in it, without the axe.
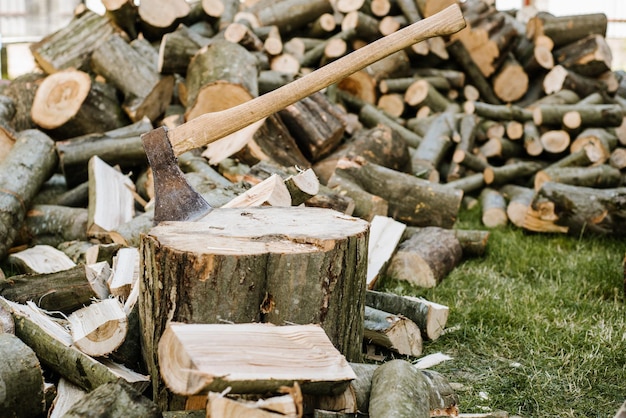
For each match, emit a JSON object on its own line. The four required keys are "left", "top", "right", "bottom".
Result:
{"left": 139, "top": 207, "right": 369, "bottom": 409}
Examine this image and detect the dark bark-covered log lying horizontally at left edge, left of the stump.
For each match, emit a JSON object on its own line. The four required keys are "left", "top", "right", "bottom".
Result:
{"left": 0, "top": 264, "right": 108, "bottom": 314}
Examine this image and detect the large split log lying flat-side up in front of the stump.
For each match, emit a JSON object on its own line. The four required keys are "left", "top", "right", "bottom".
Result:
{"left": 159, "top": 322, "right": 355, "bottom": 395}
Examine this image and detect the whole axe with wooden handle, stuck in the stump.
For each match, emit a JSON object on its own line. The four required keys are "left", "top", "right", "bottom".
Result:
{"left": 141, "top": 4, "right": 465, "bottom": 224}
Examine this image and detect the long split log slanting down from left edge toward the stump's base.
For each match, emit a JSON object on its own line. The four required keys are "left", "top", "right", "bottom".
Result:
{"left": 0, "top": 298, "right": 149, "bottom": 392}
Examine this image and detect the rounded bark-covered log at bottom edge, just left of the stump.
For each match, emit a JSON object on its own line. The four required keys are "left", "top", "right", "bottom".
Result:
{"left": 63, "top": 382, "right": 162, "bottom": 418}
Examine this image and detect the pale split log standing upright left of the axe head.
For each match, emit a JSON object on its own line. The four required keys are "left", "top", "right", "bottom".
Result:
{"left": 88, "top": 157, "right": 135, "bottom": 236}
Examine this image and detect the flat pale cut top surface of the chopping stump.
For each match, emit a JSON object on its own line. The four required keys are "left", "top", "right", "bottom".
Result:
{"left": 148, "top": 206, "right": 369, "bottom": 254}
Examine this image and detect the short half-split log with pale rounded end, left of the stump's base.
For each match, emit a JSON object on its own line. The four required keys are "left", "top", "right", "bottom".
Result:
{"left": 68, "top": 298, "right": 128, "bottom": 357}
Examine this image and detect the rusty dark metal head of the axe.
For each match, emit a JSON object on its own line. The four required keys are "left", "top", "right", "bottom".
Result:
{"left": 141, "top": 127, "right": 211, "bottom": 225}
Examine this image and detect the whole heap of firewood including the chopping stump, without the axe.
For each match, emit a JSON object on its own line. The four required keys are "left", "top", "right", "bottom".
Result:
{"left": 0, "top": 0, "right": 626, "bottom": 417}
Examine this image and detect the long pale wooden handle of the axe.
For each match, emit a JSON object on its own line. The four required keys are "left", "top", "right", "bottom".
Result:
{"left": 167, "top": 4, "right": 465, "bottom": 155}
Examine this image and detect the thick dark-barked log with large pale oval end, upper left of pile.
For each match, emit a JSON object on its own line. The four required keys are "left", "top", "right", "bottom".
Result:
{"left": 31, "top": 69, "right": 128, "bottom": 139}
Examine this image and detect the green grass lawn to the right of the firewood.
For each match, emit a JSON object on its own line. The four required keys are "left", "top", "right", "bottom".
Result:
{"left": 383, "top": 210, "right": 626, "bottom": 418}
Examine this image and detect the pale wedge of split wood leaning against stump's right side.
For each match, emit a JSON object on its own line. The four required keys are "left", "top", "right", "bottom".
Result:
{"left": 366, "top": 216, "right": 406, "bottom": 289}
